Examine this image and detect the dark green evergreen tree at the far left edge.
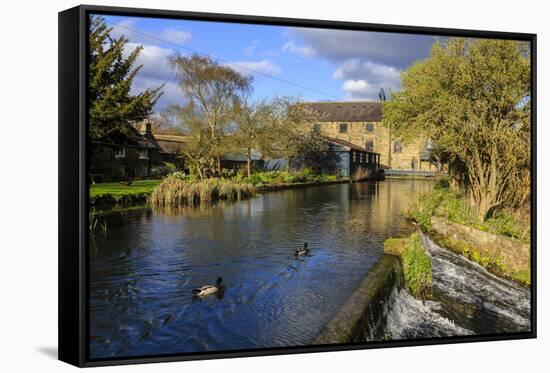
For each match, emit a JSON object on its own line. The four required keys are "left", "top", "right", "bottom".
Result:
{"left": 88, "top": 16, "right": 163, "bottom": 141}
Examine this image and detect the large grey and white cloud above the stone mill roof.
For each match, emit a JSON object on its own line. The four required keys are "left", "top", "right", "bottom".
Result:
{"left": 283, "top": 28, "right": 434, "bottom": 100}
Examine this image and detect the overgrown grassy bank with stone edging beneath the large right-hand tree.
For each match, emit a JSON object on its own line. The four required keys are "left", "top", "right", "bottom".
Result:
{"left": 407, "top": 182, "right": 531, "bottom": 285}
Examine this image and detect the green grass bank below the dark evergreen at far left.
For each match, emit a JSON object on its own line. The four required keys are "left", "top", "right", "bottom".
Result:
{"left": 90, "top": 180, "right": 162, "bottom": 206}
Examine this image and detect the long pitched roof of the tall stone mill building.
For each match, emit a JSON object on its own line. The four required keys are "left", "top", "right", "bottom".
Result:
{"left": 307, "top": 101, "right": 382, "bottom": 122}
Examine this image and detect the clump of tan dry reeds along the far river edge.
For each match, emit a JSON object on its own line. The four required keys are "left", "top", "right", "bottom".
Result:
{"left": 149, "top": 175, "right": 255, "bottom": 207}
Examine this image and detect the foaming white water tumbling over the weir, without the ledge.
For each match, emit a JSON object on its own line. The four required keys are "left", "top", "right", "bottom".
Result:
{"left": 376, "top": 235, "right": 531, "bottom": 340}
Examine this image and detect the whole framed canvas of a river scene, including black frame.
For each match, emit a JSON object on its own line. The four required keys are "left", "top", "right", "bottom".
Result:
{"left": 59, "top": 6, "right": 536, "bottom": 367}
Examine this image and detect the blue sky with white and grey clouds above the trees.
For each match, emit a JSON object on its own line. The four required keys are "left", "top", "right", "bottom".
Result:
{"left": 104, "top": 16, "right": 434, "bottom": 112}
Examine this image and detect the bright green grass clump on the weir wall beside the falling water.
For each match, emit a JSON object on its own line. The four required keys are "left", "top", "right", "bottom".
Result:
{"left": 384, "top": 233, "right": 432, "bottom": 299}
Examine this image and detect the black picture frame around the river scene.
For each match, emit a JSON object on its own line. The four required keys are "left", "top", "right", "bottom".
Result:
{"left": 58, "top": 5, "right": 537, "bottom": 367}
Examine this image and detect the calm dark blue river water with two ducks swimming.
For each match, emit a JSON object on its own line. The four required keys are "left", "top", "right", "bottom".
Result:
{"left": 89, "top": 180, "right": 432, "bottom": 358}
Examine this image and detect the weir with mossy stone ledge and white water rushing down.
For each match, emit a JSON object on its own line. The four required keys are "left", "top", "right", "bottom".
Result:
{"left": 314, "top": 233, "right": 531, "bottom": 344}
